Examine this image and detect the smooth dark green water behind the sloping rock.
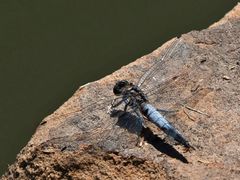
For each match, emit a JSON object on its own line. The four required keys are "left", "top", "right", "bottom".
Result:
{"left": 0, "top": 0, "right": 237, "bottom": 174}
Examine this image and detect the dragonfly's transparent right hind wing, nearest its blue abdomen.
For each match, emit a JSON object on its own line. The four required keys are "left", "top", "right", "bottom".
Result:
{"left": 147, "top": 65, "right": 212, "bottom": 108}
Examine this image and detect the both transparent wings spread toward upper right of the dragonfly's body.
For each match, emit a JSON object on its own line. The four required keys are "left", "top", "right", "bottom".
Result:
{"left": 140, "top": 36, "right": 212, "bottom": 112}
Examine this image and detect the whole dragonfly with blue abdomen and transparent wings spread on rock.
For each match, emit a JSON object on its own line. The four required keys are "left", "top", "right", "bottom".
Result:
{"left": 49, "top": 38, "right": 210, "bottom": 150}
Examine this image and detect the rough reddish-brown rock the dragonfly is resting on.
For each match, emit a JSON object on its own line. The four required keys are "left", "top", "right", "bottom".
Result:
{"left": 2, "top": 4, "right": 240, "bottom": 179}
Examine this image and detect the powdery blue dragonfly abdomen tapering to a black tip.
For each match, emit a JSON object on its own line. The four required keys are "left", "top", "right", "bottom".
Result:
{"left": 142, "top": 103, "right": 190, "bottom": 148}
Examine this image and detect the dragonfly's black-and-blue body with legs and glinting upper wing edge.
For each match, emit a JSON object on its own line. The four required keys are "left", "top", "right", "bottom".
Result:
{"left": 109, "top": 39, "right": 193, "bottom": 148}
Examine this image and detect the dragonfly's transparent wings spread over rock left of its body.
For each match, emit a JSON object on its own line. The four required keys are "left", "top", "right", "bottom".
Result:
{"left": 49, "top": 84, "right": 142, "bottom": 150}
